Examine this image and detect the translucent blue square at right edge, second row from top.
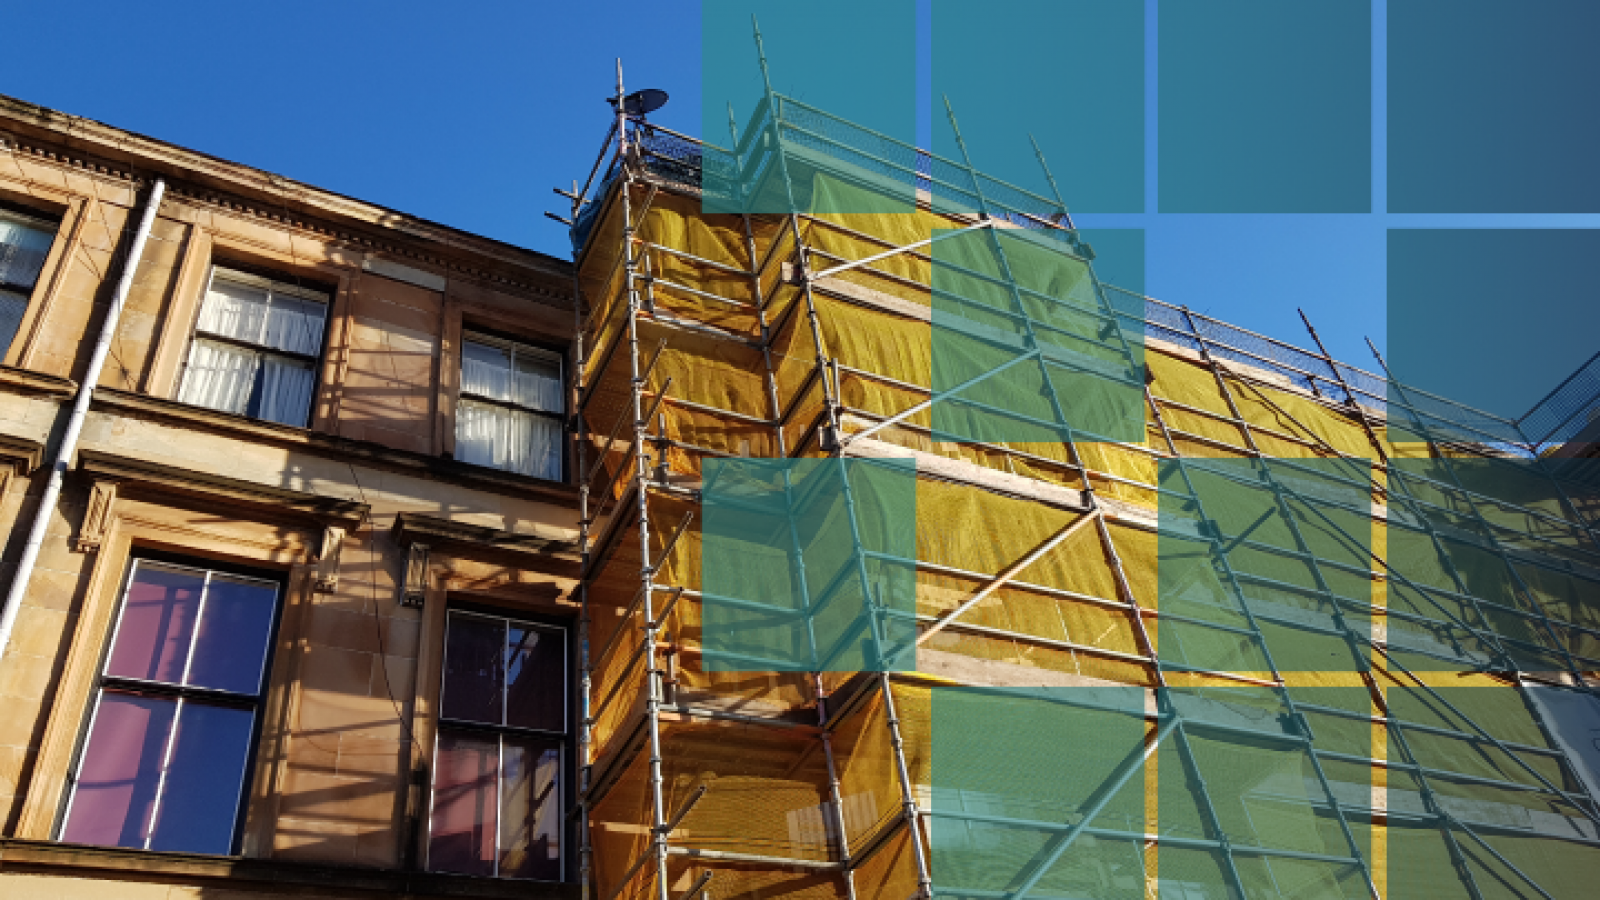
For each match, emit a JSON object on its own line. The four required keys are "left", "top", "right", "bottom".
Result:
{"left": 1387, "top": 229, "right": 1600, "bottom": 444}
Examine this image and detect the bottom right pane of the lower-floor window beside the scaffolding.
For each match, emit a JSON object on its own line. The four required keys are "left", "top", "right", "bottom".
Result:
{"left": 499, "top": 738, "right": 562, "bottom": 881}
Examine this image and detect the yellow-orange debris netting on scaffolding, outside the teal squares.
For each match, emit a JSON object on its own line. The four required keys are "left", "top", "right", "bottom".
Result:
{"left": 578, "top": 153, "right": 1600, "bottom": 900}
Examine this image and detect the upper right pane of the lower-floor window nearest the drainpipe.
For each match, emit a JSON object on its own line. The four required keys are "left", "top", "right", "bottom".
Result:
{"left": 187, "top": 575, "right": 278, "bottom": 693}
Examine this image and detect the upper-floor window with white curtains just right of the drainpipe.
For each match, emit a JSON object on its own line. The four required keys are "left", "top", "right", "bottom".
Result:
{"left": 178, "top": 267, "right": 328, "bottom": 428}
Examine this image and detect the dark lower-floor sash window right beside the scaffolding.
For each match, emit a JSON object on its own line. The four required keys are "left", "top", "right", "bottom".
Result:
{"left": 427, "top": 610, "right": 566, "bottom": 881}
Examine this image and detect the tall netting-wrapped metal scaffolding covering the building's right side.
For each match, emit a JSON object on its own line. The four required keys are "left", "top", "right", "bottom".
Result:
{"left": 571, "top": 47, "right": 1600, "bottom": 900}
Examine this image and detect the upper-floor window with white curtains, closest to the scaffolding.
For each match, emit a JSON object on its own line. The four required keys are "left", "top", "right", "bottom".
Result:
{"left": 456, "top": 333, "right": 565, "bottom": 480}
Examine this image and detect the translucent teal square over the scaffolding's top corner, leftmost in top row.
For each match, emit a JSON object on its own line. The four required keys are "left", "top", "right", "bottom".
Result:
{"left": 700, "top": 0, "right": 918, "bottom": 215}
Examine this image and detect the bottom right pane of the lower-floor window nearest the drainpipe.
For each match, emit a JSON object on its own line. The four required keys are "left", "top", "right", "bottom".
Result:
{"left": 150, "top": 701, "right": 254, "bottom": 854}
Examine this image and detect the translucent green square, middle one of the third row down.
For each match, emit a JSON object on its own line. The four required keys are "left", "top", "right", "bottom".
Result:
{"left": 1155, "top": 458, "right": 1374, "bottom": 673}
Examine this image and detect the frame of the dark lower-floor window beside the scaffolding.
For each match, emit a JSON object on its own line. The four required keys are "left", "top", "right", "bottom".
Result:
{"left": 419, "top": 604, "right": 574, "bottom": 884}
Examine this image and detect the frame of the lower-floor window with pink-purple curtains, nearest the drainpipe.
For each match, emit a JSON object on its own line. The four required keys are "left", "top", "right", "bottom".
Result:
{"left": 51, "top": 551, "right": 288, "bottom": 855}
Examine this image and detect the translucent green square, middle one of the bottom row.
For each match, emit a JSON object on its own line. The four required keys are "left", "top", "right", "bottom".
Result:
{"left": 1157, "top": 685, "right": 1371, "bottom": 900}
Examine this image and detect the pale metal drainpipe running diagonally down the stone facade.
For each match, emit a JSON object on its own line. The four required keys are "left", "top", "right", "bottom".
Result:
{"left": 0, "top": 178, "right": 166, "bottom": 660}
